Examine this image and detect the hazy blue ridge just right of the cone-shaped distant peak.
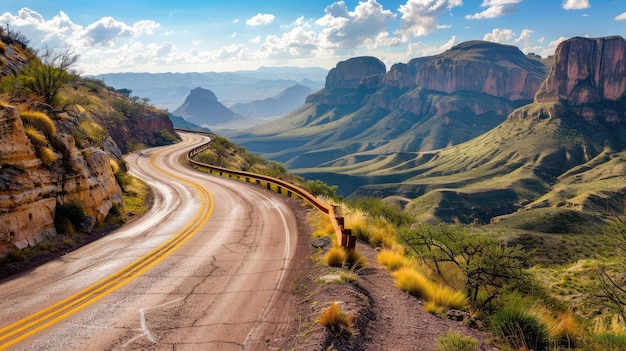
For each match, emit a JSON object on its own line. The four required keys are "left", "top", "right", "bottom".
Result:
{"left": 230, "top": 84, "right": 312, "bottom": 117}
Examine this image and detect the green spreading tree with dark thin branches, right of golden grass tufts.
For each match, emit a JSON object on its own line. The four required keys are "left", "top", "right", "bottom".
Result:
{"left": 399, "top": 223, "right": 529, "bottom": 311}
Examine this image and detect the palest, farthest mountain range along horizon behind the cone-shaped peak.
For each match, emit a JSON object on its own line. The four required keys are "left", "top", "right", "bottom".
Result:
{"left": 94, "top": 67, "right": 328, "bottom": 111}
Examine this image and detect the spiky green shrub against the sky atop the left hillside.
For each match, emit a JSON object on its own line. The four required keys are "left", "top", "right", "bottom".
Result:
{"left": 18, "top": 47, "right": 79, "bottom": 106}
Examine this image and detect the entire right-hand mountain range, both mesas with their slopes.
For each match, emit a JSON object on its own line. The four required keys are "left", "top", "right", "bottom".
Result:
{"left": 224, "top": 37, "right": 626, "bottom": 228}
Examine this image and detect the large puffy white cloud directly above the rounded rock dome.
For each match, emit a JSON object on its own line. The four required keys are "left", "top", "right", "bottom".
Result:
{"left": 315, "top": 0, "right": 395, "bottom": 49}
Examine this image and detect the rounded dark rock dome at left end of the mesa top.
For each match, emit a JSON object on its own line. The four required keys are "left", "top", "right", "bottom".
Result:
{"left": 325, "top": 56, "right": 387, "bottom": 89}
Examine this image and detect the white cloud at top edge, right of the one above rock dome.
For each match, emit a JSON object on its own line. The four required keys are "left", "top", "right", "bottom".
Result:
{"left": 396, "top": 0, "right": 463, "bottom": 41}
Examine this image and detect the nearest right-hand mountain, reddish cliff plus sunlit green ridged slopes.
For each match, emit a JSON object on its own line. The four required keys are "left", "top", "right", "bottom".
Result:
{"left": 305, "top": 37, "right": 626, "bottom": 231}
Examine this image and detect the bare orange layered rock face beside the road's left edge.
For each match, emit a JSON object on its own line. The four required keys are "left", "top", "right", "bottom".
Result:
{"left": 0, "top": 106, "right": 123, "bottom": 255}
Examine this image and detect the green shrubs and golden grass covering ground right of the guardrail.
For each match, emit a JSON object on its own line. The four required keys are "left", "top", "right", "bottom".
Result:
{"left": 189, "top": 133, "right": 626, "bottom": 351}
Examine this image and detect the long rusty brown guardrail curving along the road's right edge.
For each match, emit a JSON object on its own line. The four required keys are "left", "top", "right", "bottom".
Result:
{"left": 176, "top": 129, "right": 356, "bottom": 250}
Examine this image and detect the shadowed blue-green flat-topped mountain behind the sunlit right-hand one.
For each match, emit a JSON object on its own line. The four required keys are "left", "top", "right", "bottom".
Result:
{"left": 228, "top": 41, "right": 545, "bottom": 168}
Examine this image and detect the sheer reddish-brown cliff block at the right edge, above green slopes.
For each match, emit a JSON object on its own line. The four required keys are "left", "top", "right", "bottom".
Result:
{"left": 535, "top": 37, "right": 626, "bottom": 105}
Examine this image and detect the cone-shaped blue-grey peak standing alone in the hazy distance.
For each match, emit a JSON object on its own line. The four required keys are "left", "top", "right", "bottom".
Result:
{"left": 172, "top": 87, "right": 244, "bottom": 127}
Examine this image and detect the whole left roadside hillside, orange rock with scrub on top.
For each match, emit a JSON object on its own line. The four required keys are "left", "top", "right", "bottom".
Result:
{"left": 0, "top": 31, "right": 177, "bottom": 258}
